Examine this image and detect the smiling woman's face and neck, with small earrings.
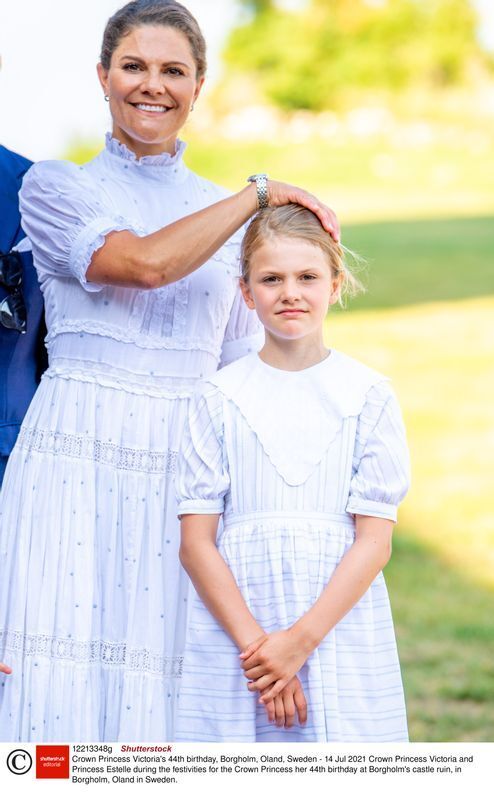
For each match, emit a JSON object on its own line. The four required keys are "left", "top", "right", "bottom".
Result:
{"left": 98, "top": 25, "right": 204, "bottom": 157}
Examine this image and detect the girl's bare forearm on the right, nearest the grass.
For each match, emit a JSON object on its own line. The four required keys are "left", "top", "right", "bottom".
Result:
{"left": 292, "top": 516, "right": 393, "bottom": 655}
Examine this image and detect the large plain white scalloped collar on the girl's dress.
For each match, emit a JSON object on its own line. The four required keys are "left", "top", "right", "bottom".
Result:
{"left": 208, "top": 350, "right": 388, "bottom": 486}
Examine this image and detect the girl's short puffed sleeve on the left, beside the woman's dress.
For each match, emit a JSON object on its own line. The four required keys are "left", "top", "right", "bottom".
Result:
{"left": 175, "top": 387, "right": 230, "bottom": 514}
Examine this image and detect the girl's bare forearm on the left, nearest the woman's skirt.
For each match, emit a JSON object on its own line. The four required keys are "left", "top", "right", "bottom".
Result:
{"left": 180, "top": 514, "right": 264, "bottom": 650}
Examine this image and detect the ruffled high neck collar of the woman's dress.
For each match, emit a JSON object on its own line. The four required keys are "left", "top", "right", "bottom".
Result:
{"left": 105, "top": 133, "right": 188, "bottom": 183}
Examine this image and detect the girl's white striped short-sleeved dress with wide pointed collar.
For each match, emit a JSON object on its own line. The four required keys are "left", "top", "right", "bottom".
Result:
{"left": 177, "top": 351, "right": 408, "bottom": 742}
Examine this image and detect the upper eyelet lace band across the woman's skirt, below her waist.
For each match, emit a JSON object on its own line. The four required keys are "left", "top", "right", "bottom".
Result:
{"left": 17, "top": 428, "right": 177, "bottom": 475}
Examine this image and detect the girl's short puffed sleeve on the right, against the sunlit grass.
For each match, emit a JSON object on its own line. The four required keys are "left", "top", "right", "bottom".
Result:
{"left": 346, "top": 382, "right": 410, "bottom": 522}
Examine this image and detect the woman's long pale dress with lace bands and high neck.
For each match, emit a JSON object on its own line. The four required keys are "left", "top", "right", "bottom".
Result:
{"left": 0, "top": 137, "right": 262, "bottom": 742}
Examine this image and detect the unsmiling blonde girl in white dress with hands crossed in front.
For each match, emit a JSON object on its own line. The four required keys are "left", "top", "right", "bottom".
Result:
{"left": 176, "top": 206, "right": 408, "bottom": 742}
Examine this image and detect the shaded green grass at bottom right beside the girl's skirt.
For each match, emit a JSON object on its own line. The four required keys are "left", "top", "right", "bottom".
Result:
{"left": 386, "top": 530, "right": 494, "bottom": 742}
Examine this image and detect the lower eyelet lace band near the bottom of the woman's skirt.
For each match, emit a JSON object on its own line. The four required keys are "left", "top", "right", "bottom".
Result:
{"left": 0, "top": 630, "right": 183, "bottom": 678}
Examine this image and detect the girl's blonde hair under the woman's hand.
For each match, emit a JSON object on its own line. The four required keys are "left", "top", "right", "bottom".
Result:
{"left": 240, "top": 203, "right": 364, "bottom": 304}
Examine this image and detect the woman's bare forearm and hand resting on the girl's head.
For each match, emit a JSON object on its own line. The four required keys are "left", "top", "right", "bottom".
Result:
{"left": 86, "top": 181, "right": 339, "bottom": 289}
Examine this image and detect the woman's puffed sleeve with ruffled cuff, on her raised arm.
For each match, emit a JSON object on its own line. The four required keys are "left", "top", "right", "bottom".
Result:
{"left": 19, "top": 161, "right": 147, "bottom": 292}
